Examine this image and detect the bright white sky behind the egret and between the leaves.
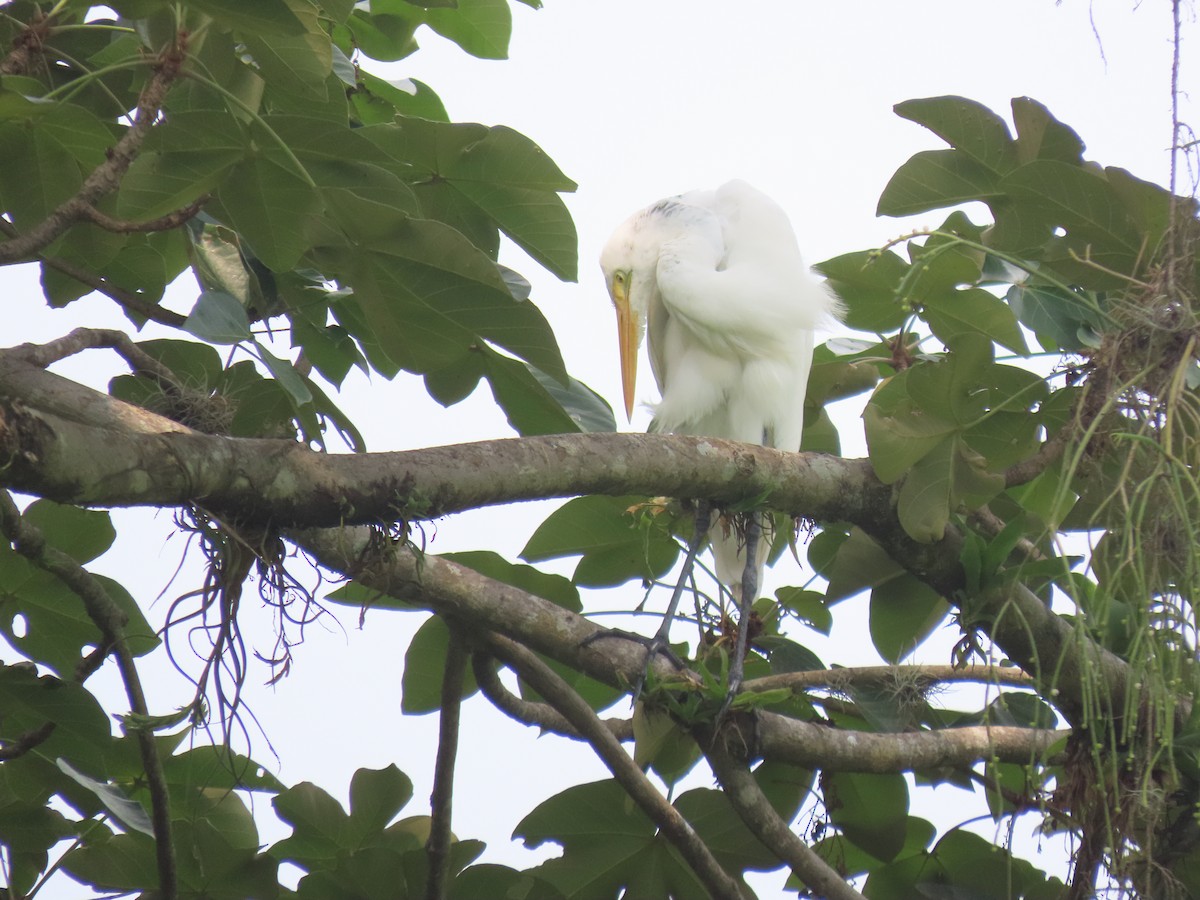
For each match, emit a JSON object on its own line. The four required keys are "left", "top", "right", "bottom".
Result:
{"left": 11, "top": 0, "right": 1196, "bottom": 899}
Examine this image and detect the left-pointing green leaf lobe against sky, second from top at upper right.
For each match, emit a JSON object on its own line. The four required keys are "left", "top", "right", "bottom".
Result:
{"left": 876, "top": 150, "right": 1003, "bottom": 216}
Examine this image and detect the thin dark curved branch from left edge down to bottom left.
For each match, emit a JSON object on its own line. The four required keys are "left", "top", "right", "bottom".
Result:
{"left": 0, "top": 491, "right": 178, "bottom": 900}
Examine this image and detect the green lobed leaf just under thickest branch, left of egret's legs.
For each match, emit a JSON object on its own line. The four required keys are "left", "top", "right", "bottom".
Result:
{"left": 521, "top": 497, "right": 679, "bottom": 587}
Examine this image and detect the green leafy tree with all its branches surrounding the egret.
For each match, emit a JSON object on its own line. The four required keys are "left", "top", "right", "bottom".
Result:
{"left": 0, "top": 0, "right": 1200, "bottom": 900}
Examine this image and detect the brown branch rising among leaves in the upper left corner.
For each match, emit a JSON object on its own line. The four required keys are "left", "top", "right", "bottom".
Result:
{"left": 0, "top": 43, "right": 186, "bottom": 264}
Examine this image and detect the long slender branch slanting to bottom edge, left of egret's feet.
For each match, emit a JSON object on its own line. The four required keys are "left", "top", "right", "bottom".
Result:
{"left": 485, "top": 634, "right": 745, "bottom": 900}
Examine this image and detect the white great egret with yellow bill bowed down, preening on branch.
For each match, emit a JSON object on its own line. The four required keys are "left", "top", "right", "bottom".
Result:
{"left": 600, "top": 181, "right": 839, "bottom": 695}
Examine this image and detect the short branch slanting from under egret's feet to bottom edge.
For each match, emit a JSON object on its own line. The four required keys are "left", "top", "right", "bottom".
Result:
{"left": 694, "top": 722, "right": 864, "bottom": 900}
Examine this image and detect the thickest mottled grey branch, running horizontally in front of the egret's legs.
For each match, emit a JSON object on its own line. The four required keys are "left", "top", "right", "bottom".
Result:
{"left": 0, "top": 348, "right": 1129, "bottom": 724}
